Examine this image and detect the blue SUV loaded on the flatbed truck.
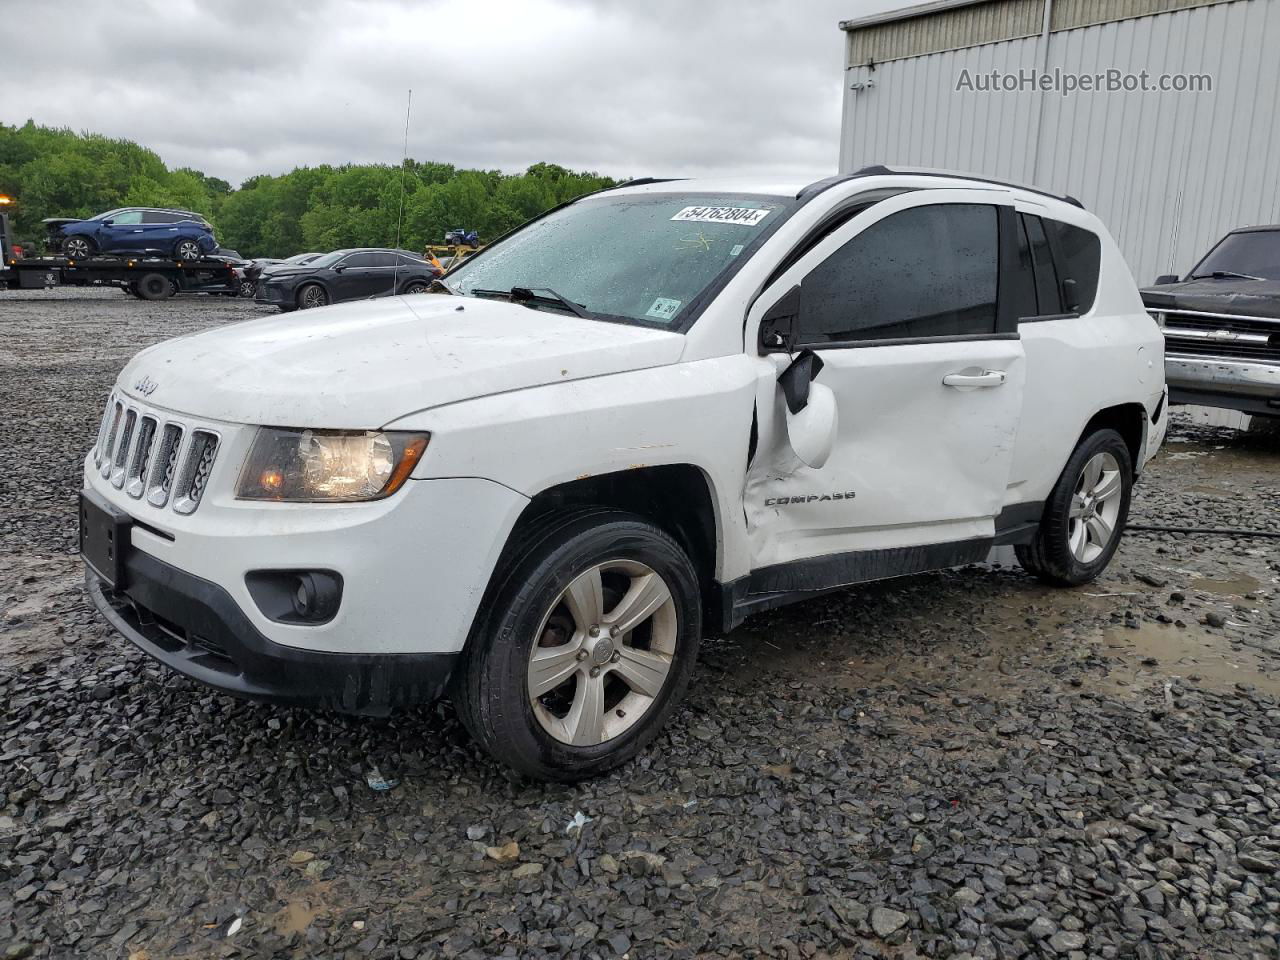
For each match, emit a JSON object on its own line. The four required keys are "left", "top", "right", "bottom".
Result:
{"left": 45, "top": 206, "right": 218, "bottom": 260}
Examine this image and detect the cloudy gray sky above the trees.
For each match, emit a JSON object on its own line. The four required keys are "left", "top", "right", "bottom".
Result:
{"left": 0, "top": 0, "right": 905, "bottom": 184}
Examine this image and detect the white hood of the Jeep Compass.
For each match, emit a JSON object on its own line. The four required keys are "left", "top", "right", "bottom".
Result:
{"left": 119, "top": 294, "right": 685, "bottom": 429}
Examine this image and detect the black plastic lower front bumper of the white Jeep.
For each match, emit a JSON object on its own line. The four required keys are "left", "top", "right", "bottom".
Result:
{"left": 84, "top": 550, "right": 457, "bottom": 716}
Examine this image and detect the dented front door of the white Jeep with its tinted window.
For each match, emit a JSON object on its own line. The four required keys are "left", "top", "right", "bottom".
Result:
{"left": 746, "top": 189, "right": 1025, "bottom": 593}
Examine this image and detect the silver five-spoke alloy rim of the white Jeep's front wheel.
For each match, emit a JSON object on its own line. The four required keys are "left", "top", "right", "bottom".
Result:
{"left": 527, "top": 559, "right": 678, "bottom": 746}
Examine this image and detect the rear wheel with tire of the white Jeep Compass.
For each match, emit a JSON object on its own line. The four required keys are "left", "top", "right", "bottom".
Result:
{"left": 1014, "top": 430, "right": 1133, "bottom": 586}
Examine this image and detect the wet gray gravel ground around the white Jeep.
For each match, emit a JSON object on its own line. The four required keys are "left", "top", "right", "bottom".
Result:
{"left": 0, "top": 291, "right": 1280, "bottom": 960}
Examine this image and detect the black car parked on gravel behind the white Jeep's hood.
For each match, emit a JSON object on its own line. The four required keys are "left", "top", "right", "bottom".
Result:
{"left": 255, "top": 248, "right": 440, "bottom": 310}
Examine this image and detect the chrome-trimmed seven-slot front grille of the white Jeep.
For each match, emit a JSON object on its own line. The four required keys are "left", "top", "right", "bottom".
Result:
{"left": 93, "top": 397, "right": 220, "bottom": 513}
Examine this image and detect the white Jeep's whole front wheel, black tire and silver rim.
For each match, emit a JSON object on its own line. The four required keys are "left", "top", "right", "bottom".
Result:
{"left": 453, "top": 508, "right": 701, "bottom": 781}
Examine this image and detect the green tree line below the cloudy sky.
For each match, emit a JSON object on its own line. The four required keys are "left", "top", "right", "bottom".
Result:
{"left": 0, "top": 120, "right": 614, "bottom": 257}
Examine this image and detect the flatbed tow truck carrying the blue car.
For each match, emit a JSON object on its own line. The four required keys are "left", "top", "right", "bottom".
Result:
{"left": 0, "top": 196, "right": 239, "bottom": 300}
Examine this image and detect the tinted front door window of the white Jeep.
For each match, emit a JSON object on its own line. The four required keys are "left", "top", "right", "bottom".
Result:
{"left": 800, "top": 204, "right": 1000, "bottom": 343}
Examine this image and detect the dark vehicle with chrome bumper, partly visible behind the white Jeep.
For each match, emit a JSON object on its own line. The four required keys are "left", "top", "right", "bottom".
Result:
{"left": 1142, "top": 225, "right": 1280, "bottom": 416}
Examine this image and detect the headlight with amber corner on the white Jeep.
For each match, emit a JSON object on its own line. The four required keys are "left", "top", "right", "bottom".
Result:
{"left": 236, "top": 426, "right": 430, "bottom": 503}
